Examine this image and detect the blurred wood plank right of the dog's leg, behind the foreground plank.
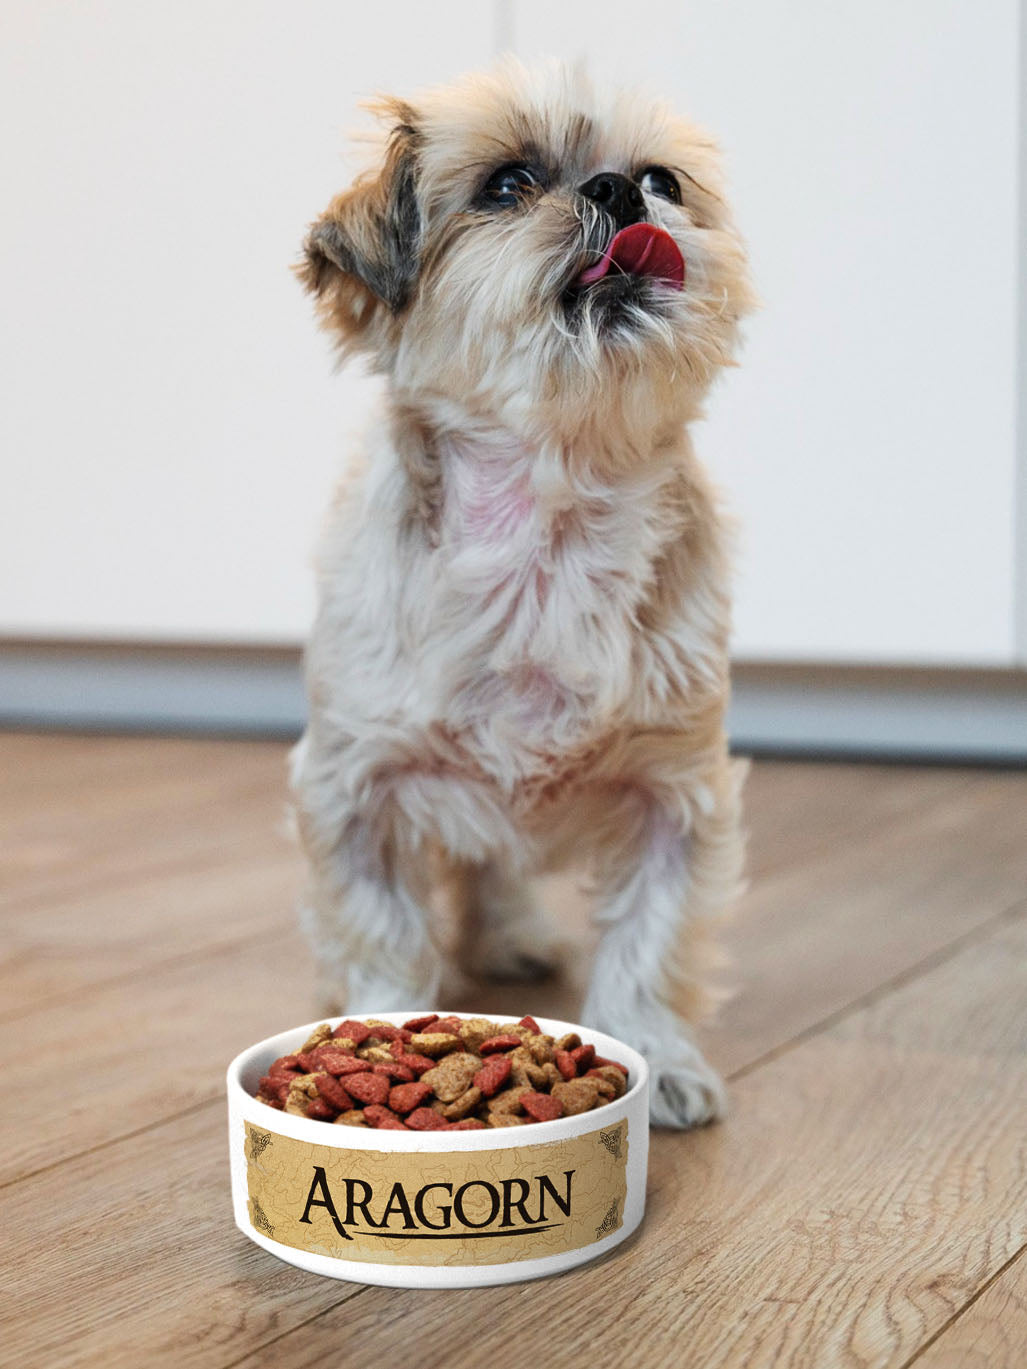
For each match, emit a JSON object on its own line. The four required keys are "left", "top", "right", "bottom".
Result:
{"left": 704, "top": 773, "right": 1027, "bottom": 1073}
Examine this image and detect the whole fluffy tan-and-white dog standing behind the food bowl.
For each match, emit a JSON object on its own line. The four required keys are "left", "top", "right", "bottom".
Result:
{"left": 293, "top": 62, "right": 750, "bottom": 1127}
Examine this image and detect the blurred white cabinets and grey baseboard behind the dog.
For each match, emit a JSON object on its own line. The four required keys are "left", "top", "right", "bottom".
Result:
{"left": 0, "top": 0, "right": 1027, "bottom": 760}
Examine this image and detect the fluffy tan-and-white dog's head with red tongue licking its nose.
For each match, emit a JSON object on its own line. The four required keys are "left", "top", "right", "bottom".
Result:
{"left": 300, "top": 60, "right": 750, "bottom": 426}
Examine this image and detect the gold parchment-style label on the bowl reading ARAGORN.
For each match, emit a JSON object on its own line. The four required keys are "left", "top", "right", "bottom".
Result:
{"left": 244, "top": 1117, "right": 629, "bottom": 1265}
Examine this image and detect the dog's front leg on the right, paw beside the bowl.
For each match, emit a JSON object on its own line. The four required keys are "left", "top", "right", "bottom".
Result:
{"left": 582, "top": 777, "right": 741, "bottom": 1127}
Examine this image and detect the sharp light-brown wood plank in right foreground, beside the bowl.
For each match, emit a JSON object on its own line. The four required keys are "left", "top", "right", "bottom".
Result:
{"left": 228, "top": 917, "right": 1027, "bottom": 1369}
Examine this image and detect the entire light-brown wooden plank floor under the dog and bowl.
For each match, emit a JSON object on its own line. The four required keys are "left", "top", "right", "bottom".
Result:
{"left": 0, "top": 735, "right": 1027, "bottom": 1369}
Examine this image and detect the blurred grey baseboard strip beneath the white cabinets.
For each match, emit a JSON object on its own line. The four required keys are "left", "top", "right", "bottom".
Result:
{"left": 0, "top": 642, "right": 1027, "bottom": 764}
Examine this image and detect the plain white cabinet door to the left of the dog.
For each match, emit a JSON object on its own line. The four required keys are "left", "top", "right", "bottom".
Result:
{"left": 0, "top": 0, "right": 494, "bottom": 642}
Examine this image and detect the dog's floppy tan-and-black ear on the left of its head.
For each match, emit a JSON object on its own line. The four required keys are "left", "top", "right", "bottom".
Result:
{"left": 296, "top": 101, "right": 422, "bottom": 344}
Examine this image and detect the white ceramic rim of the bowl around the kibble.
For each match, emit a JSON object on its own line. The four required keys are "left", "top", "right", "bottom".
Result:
{"left": 226, "top": 1009, "right": 649, "bottom": 1151}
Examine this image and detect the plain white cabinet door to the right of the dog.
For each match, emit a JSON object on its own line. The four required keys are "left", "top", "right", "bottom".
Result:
{"left": 512, "top": 0, "right": 1024, "bottom": 664}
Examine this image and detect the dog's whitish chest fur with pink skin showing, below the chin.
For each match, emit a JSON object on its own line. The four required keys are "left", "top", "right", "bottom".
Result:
{"left": 431, "top": 448, "right": 660, "bottom": 756}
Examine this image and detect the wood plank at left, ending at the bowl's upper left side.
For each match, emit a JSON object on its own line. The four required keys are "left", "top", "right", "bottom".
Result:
{"left": 0, "top": 934, "right": 316, "bottom": 1184}
